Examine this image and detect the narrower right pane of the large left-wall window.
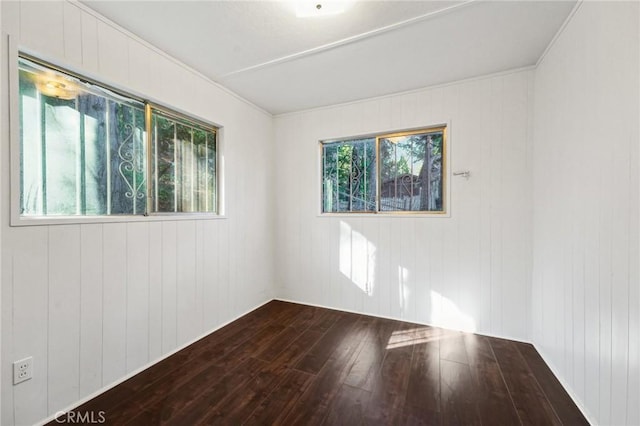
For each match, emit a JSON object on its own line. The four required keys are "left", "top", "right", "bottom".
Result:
{"left": 152, "top": 110, "right": 217, "bottom": 212}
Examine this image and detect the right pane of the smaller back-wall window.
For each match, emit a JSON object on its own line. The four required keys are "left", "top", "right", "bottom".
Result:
{"left": 379, "top": 130, "right": 443, "bottom": 211}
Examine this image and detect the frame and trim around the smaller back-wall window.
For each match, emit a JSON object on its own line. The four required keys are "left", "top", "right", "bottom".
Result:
{"left": 316, "top": 120, "right": 451, "bottom": 218}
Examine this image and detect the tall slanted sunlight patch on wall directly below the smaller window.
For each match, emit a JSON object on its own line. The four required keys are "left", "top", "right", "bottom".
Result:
{"left": 340, "top": 221, "right": 376, "bottom": 296}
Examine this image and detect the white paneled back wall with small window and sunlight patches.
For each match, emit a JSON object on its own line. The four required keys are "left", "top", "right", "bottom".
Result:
{"left": 275, "top": 70, "right": 532, "bottom": 340}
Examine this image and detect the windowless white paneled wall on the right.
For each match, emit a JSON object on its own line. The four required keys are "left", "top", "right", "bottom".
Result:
{"left": 532, "top": 2, "right": 640, "bottom": 425}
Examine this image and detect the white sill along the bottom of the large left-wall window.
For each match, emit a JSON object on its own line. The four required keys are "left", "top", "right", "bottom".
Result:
{"left": 11, "top": 213, "right": 227, "bottom": 227}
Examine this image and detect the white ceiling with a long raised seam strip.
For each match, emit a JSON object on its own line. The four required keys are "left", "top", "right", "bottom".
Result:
{"left": 84, "top": 0, "right": 576, "bottom": 114}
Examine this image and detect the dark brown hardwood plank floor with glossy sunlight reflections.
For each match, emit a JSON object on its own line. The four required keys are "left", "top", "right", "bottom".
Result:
{"left": 55, "top": 301, "right": 588, "bottom": 425}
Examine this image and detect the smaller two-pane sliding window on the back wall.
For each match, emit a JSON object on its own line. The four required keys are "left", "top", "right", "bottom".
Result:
{"left": 321, "top": 126, "right": 446, "bottom": 214}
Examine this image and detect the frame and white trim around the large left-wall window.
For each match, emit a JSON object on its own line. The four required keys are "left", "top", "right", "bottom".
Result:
{"left": 5, "top": 43, "right": 226, "bottom": 226}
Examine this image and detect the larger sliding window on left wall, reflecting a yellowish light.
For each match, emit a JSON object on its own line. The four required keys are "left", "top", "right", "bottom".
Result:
{"left": 18, "top": 57, "right": 217, "bottom": 217}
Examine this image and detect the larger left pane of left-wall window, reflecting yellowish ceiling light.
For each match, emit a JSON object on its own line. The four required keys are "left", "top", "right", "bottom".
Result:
{"left": 19, "top": 58, "right": 146, "bottom": 216}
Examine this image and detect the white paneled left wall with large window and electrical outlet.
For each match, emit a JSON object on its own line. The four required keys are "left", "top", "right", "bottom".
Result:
{"left": 0, "top": 1, "right": 274, "bottom": 425}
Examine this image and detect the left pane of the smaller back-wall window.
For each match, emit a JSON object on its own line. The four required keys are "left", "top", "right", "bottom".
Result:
{"left": 322, "top": 139, "right": 377, "bottom": 213}
